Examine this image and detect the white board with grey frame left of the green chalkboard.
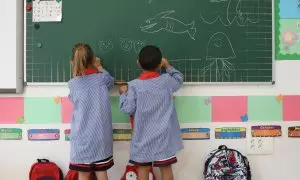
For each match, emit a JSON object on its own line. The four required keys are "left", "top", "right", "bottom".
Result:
{"left": 0, "top": 0, "right": 23, "bottom": 93}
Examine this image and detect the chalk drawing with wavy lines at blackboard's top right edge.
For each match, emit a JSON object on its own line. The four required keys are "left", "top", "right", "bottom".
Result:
{"left": 200, "top": 0, "right": 259, "bottom": 26}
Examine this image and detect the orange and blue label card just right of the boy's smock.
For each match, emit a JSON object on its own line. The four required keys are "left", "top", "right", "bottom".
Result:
{"left": 181, "top": 128, "right": 210, "bottom": 140}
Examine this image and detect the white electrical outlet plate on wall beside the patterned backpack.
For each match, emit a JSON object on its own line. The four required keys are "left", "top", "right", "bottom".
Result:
{"left": 247, "top": 137, "right": 274, "bottom": 155}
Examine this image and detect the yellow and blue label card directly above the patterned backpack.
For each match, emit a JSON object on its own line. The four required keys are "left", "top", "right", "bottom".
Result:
{"left": 215, "top": 127, "right": 246, "bottom": 139}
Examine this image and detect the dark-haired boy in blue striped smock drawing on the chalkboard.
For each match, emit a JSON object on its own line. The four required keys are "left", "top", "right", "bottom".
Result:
{"left": 120, "top": 46, "right": 183, "bottom": 180}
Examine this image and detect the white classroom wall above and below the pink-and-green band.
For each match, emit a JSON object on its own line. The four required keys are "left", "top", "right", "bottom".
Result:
{"left": 0, "top": 0, "right": 300, "bottom": 180}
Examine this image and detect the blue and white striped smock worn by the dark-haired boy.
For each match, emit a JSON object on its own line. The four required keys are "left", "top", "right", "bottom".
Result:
{"left": 120, "top": 67, "right": 183, "bottom": 163}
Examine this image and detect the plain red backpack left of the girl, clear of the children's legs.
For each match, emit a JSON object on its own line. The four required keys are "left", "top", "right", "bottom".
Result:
{"left": 29, "top": 159, "right": 64, "bottom": 180}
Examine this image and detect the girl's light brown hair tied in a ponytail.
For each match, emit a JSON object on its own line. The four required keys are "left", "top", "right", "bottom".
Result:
{"left": 72, "top": 43, "right": 94, "bottom": 77}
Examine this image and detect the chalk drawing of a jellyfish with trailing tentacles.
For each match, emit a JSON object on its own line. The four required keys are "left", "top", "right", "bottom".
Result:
{"left": 202, "top": 32, "right": 236, "bottom": 80}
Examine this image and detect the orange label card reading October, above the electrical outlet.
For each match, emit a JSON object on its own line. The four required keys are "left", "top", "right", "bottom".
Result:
{"left": 251, "top": 125, "right": 282, "bottom": 137}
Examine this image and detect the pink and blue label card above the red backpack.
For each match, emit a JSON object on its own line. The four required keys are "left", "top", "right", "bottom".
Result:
{"left": 28, "top": 129, "right": 60, "bottom": 141}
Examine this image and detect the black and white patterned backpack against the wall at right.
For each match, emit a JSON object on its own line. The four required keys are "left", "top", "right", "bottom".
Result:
{"left": 203, "top": 145, "right": 251, "bottom": 180}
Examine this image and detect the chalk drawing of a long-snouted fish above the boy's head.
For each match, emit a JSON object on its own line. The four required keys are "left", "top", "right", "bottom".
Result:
{"left": 140, "top": 10, "right": 197, "bottom": 40}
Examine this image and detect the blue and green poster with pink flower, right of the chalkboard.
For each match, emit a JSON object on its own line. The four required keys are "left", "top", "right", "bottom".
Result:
{"left": 274, "top": 0, "right": 300, "bottom": 60}
